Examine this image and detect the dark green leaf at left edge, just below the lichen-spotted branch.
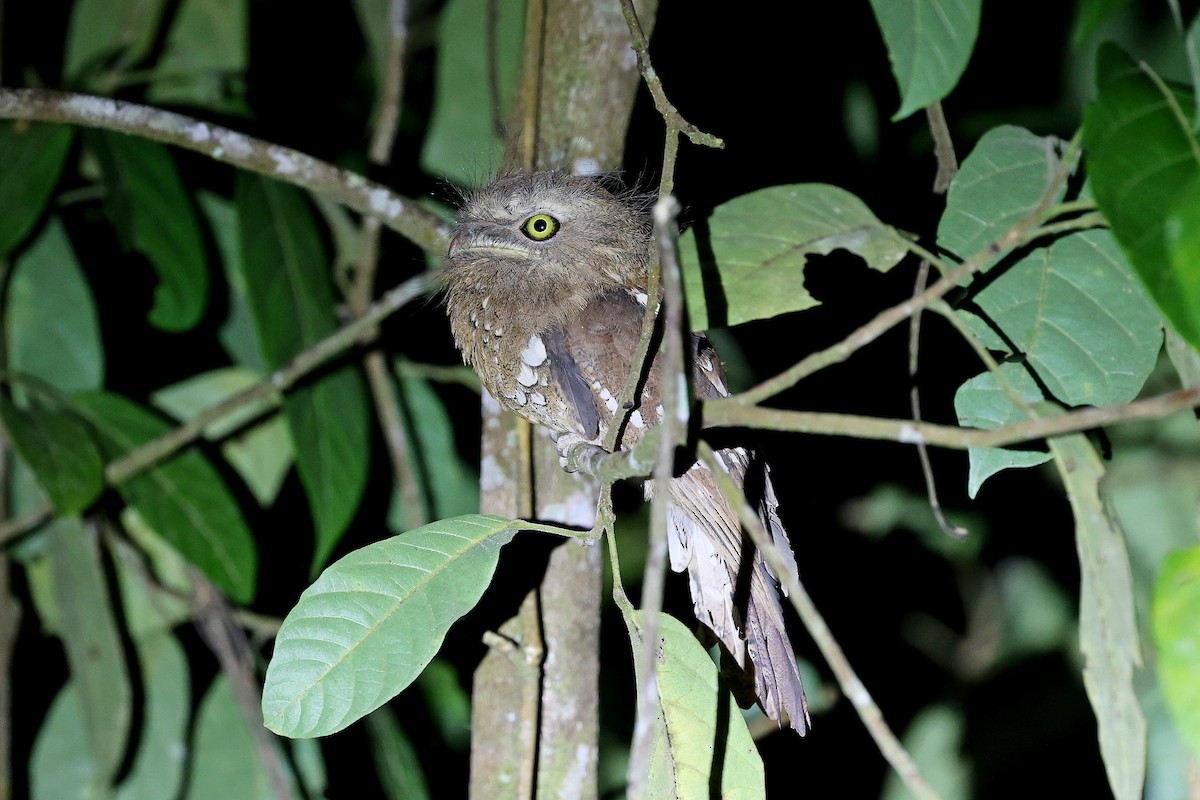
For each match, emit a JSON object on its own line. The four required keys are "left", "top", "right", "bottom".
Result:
{"left": 0, "top": 122, "right": 74, "bottom": 255}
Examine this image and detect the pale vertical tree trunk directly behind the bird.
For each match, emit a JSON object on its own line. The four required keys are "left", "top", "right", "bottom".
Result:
{"left": 470, "top": 0, "right": 655, "bottom": 800}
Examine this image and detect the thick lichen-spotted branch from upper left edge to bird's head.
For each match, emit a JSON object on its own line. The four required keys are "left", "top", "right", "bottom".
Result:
{"left": 0, "top": 89, "right": 449, "bottom": 252}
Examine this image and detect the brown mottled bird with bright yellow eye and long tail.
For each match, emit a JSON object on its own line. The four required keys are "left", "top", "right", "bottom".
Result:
{"left": 444, "top": 170, "right": 809, "bottom": 734}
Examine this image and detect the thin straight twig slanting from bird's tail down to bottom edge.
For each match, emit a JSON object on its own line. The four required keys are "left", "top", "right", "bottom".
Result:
{"left": 696, "top": 440, "right": 937, "bottom": 800}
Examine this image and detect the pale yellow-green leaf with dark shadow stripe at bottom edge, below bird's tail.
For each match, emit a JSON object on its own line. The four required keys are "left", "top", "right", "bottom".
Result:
{"left": 624, "top": 612, "right": 767, "bottom": 800}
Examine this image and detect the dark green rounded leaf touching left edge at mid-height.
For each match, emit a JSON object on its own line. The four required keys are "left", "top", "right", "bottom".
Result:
{"left": 0, "top": 393, "right": 104, "bottom": 516}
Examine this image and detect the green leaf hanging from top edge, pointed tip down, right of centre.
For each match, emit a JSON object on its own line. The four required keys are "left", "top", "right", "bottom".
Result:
{"left": 871, "top": 0, "right": 982, "bottom": 121}
